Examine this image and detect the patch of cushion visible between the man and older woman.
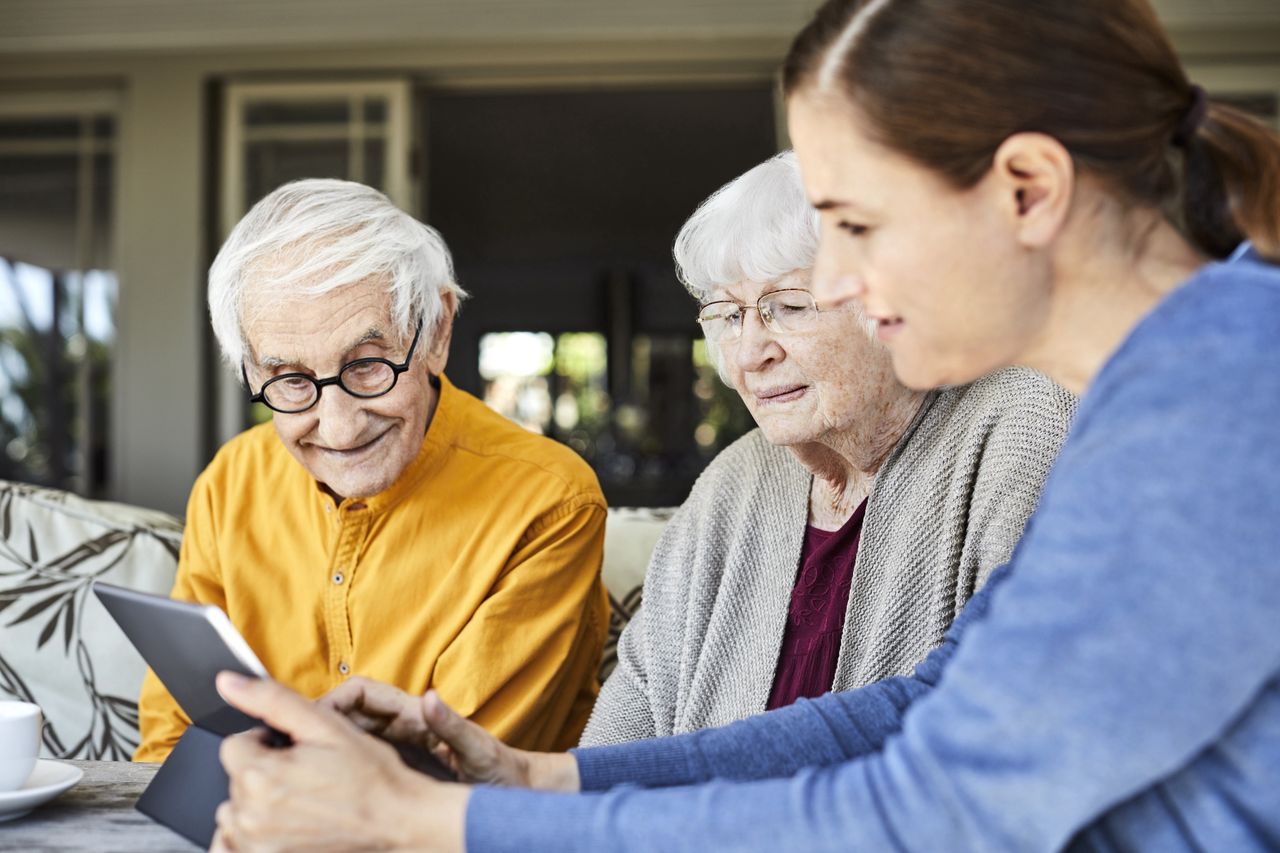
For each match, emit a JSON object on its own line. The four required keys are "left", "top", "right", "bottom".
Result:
{"left": 600, "top": 507, "right": 676, "bottom": 684}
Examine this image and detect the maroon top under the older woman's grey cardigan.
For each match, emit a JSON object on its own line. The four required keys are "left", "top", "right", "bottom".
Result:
{"left": 768, "top": 501, "right": 867, "bottom": 711}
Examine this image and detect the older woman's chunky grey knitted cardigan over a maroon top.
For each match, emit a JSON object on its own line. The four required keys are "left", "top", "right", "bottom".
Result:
{"left": 582, "top": 368, "right": 1075, "bottom": 745}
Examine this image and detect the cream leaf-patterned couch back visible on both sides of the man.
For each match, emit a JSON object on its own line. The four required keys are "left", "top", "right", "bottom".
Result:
{"left": 0, "top": 480, "right": 671, "bottom": 760}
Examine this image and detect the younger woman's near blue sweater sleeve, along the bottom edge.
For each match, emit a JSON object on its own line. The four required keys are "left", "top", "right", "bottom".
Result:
{"left": 467, "top": 272, "right": 1280, "bottom": 850}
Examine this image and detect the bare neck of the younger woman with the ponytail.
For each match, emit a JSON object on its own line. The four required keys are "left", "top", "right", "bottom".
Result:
{"left": 1020, "top": 202, "right": 1206, "bottom": 394}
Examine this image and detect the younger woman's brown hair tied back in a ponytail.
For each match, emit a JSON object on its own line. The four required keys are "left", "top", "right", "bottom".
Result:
{"left": 782, "top": 0, "right": 1280, "bottom": 261}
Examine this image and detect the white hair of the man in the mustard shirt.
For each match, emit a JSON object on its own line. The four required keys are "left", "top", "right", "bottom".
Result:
{"left": 209, "top": 178, "right": 466, "bottom": 373}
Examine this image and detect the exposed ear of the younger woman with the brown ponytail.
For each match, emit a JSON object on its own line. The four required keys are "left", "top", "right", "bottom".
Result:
{"left": 991, "top": 133, "right": 1075, "bottom": 248}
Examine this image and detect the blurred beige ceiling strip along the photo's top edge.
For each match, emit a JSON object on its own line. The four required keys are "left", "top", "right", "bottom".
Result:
{"left": 0, "top": 0, "right": 1280, "bottom": 56}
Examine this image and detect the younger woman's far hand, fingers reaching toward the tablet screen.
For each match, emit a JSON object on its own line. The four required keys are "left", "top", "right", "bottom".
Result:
{"left": 317, "top": 676, "right": 579, "bottom": 792}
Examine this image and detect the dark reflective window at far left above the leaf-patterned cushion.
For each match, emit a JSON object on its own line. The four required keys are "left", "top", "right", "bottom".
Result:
{"left": 0, "top": 115, "right": 118, "bottom": 494}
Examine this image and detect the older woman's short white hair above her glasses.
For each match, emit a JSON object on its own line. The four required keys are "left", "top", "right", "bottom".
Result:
{"left": 673, "top": 151, "right": 818, "bottom": 301}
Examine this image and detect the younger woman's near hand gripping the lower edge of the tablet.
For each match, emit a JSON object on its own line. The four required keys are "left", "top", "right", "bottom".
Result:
{"left": 212, "top": 672, "right": 470, "bottom": 853}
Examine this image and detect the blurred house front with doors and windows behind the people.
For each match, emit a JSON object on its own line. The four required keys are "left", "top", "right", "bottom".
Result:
{"left": 0, "top": 0, "right": 1280, "bottom": 514}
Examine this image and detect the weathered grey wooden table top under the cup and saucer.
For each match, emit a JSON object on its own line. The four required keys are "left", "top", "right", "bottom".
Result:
{"left": 0, "top": 761, "right": 200, "bottom": 853}
